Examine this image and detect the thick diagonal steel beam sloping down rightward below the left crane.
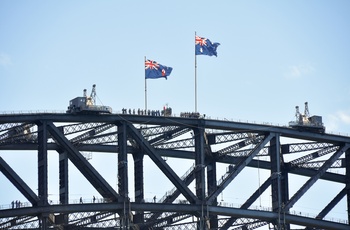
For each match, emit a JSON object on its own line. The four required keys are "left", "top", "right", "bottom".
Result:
{"left": 47, "top": 122, "right": 120, "bottom": 201}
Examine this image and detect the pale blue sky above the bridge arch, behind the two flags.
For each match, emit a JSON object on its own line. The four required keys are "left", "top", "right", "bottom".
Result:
{"left": 0, "top": 0, "right": 350, "bottom": 227}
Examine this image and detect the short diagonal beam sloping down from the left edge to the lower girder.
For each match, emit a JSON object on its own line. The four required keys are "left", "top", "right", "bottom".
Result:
{"left": 0, "top": 157, "right": 40, "bottom": 206}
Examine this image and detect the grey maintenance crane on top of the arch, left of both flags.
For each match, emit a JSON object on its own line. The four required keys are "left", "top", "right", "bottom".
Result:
{"left": 67, "top": 84, "right": 112, "bottom": 114}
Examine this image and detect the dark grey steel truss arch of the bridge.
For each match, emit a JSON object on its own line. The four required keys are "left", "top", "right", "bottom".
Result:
{"left": 0, "top": 113, "right": 350, "bottom": 229}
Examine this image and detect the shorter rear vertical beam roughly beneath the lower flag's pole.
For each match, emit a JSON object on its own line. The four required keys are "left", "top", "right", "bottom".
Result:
{"left": 133, "top": 150, "right": 145, "bottom": 224}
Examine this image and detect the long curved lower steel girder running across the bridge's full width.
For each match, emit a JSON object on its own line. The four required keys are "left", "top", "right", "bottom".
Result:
{"left": 0, "top": 203, "right": 349, "bottom": 229}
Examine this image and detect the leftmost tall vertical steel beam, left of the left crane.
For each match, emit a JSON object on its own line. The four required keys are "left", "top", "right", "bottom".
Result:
{"left": 37, "top": 121, "right": 48, "bottom": 229}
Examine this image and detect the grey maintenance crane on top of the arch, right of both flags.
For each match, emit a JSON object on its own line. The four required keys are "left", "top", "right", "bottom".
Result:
{"left": 289, "top": 102, "right": 326, "bottom": 133}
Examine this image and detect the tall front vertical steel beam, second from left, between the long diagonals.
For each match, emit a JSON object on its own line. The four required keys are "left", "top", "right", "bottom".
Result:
{"left": 118, "top": 122, "right": 130, "bottom": 229}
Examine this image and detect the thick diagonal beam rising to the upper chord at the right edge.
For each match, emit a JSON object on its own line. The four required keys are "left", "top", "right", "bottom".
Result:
{"left": 284, "top": 144, "right": 349, "bottom": 210}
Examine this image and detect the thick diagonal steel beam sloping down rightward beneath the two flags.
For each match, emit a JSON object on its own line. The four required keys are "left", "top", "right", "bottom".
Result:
{"left": 127, "top": 124, "right": 199, "bottom": 204}
